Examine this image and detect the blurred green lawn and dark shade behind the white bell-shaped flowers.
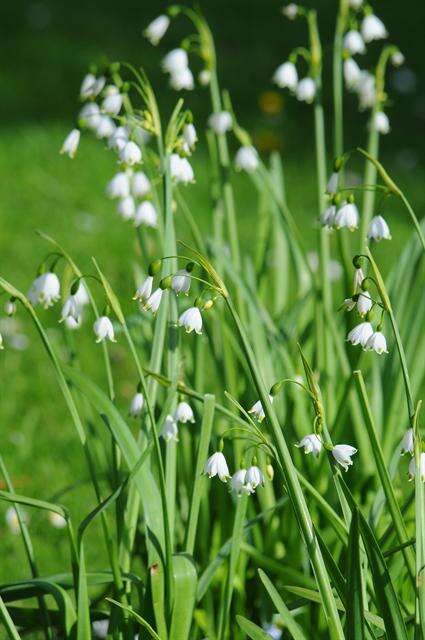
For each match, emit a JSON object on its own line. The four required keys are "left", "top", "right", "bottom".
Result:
{"left": 0, "top": 0, "right": 425, "bottom": 592}
